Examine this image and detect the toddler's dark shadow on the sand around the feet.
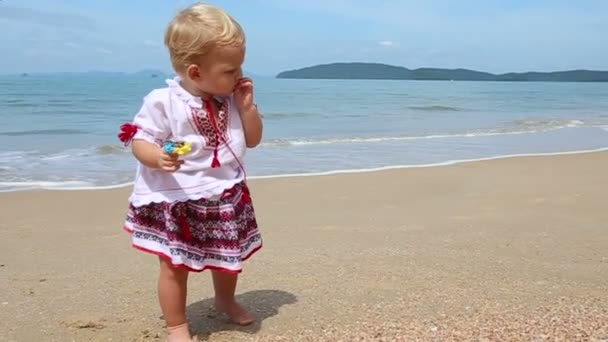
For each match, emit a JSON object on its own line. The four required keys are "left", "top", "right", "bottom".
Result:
{"left": 186, "top": 290, "right": 298, "bottom": 340}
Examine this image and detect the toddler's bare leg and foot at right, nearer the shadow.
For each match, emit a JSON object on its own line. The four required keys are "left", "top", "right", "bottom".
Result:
{"left": 212, "top": 271, "right": 255, "bottom": 325}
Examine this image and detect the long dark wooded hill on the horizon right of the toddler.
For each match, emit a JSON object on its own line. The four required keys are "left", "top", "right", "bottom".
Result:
{"left": 276, "top": 63, "right": 608, "bottom": 82}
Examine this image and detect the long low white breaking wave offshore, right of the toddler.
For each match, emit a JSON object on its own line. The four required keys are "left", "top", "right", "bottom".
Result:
{"left": 262, "top": 120, "right": 584, "bottom": 147}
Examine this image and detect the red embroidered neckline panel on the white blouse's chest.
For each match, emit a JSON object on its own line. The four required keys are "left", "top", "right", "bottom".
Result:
{"left": 192, "top": 101, "right": 230, "bottom": 149}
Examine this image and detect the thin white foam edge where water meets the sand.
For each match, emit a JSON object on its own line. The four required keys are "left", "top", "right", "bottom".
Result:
{"left": 0, "top": 146, "right": 608, "bottom": 196}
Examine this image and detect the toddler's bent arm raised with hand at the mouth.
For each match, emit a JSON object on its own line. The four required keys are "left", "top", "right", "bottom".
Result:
{"left": 234, "top": 77, "right": 264, "bottom": 148}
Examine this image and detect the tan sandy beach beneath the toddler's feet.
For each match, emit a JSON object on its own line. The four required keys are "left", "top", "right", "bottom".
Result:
{"left": 0, "top": 152, "right": 608, "bottom": 342}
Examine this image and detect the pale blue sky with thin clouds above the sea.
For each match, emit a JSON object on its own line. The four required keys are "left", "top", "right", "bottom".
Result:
{"left": 0, "top": 0, "right": 608, "bottom": 75}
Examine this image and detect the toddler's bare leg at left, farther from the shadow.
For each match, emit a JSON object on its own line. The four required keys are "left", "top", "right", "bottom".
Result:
{"left": 158, "top": 258, "right": 191, "bottom": 342}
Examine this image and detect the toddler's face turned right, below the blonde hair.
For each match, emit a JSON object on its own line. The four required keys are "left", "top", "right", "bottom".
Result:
{"left": 188, "top": 46, "right": 245, "bottom": 96}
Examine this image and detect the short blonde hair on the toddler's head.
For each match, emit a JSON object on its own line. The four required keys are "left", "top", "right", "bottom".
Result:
{"left": 165, "top": 3, "right": 245, "bottom": 72}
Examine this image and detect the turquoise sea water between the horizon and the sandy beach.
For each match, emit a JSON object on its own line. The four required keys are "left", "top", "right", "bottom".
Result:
{"left": 0, "top": 74, "right": 608, "bottom": 191}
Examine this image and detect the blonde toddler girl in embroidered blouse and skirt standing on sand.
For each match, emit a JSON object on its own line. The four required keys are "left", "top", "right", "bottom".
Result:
{"left": 119, "top": 4, "right": 262, "bottom": 342}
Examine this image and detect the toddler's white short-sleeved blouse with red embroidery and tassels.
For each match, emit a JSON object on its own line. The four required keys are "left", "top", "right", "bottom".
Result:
{"left": 121, "top": 77, "right": 247, "bottom": 206}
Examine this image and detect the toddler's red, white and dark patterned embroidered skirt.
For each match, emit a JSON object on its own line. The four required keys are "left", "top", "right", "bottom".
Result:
{"left": 125, "top": 183, "right": 262, "bottom": 273}
